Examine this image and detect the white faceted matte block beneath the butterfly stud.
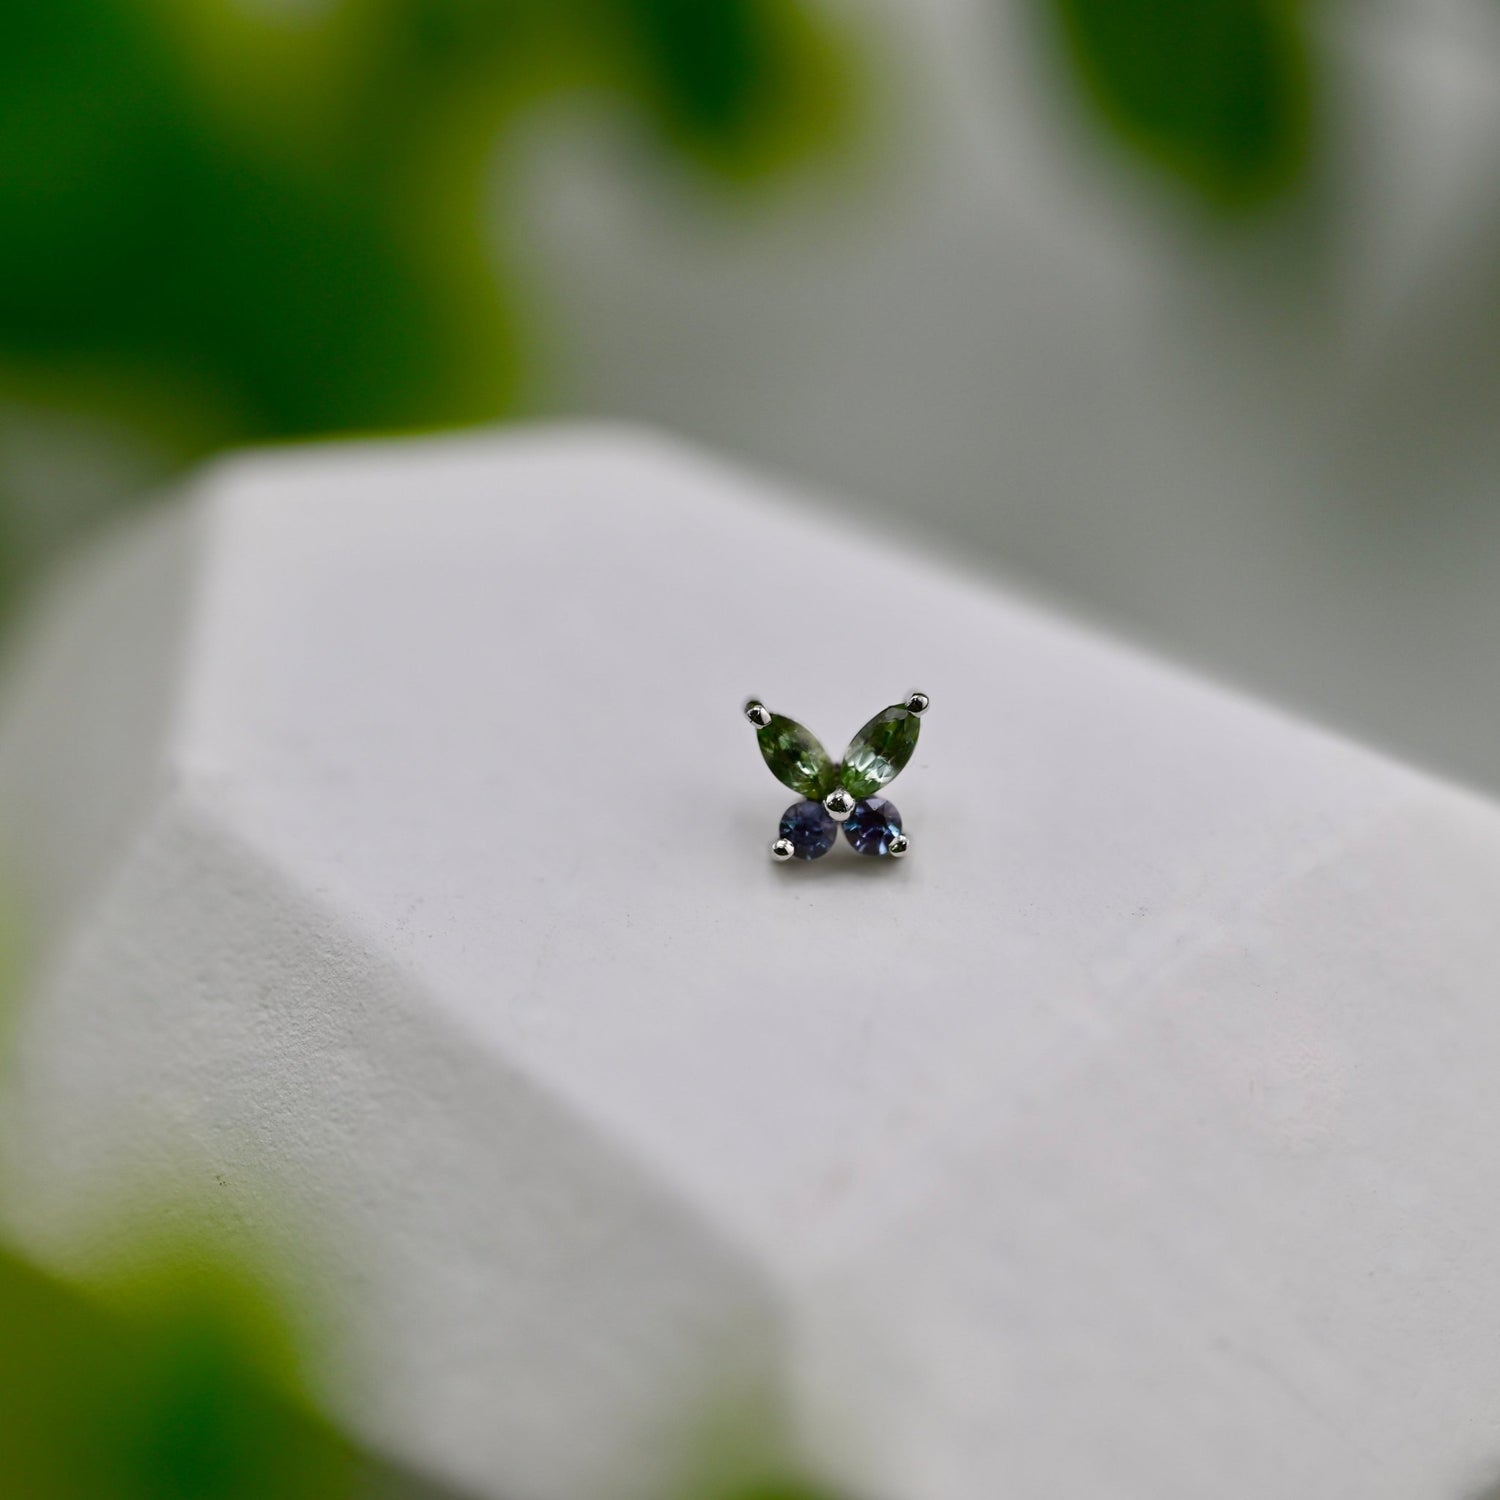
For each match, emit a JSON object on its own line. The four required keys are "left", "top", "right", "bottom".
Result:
{"left": 0, "top": 429, "right": 1500, "bottom": 1500}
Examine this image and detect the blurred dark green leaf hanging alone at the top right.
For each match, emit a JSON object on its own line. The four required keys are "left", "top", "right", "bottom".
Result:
{"left": 1049, "top": 0, "right": 1311, "bottom": 210}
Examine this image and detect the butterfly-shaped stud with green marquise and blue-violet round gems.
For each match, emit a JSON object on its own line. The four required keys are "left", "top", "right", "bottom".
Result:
{"left": 746, "top": 693, "right": 929, "bottom": 863}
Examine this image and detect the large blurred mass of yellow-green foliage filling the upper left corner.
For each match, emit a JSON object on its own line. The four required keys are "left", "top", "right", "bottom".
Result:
{"left": 0, "top": 0, "right": 845, "bottom": 621}
